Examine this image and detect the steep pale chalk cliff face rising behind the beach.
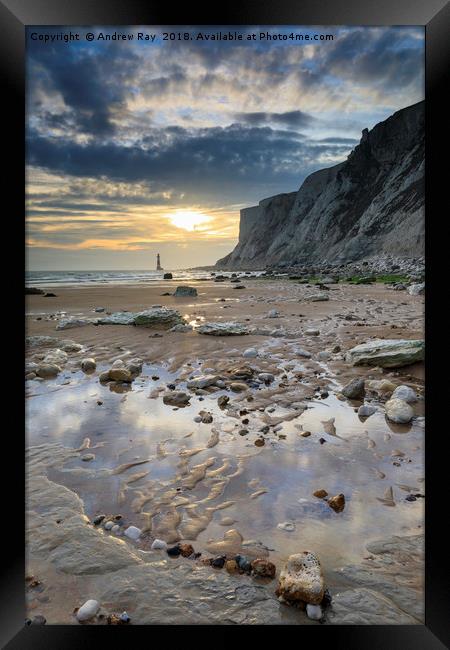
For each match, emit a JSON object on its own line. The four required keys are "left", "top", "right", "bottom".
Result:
{"left": 216, "top": 102, "right": 425, "bottom": 269}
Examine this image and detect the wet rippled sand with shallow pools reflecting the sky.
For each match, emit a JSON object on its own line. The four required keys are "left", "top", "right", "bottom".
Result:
{"left": 26, "top": 278, "right": 425, "bottom": 624}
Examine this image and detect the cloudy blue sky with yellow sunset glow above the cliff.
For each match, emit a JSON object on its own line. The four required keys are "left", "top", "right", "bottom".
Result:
{"left": 26, "top": 26, "right": 424, "bottom": 270}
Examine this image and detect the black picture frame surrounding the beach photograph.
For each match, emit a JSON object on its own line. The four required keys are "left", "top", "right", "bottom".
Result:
{"left": 4, "top": 0, "right": 450, "bottom": 650}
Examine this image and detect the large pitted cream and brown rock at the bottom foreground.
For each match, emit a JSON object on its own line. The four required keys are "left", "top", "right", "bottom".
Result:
{"left": 276, "top": 551, "right": 325, "bottom": 605}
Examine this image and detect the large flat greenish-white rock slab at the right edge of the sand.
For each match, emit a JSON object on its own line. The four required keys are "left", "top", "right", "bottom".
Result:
{"left": 345, "top": 339, "right": 425, "bottom": 368}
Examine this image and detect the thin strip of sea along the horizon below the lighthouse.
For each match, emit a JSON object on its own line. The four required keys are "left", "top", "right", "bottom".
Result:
{"left": 25, "top": 269, "right": 262, "bottom": 287}
